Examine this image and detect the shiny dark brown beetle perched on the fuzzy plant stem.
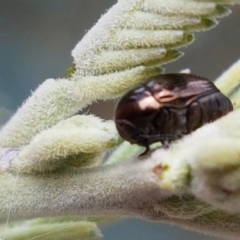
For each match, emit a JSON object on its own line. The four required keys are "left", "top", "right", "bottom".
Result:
{"left": 115, "top": 73, "right": 233, "bottom": 154}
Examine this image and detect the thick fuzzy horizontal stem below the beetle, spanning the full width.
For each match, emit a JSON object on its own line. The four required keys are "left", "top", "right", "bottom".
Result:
{"left": 0, "top": 154, "right": 240, "bottom": 239}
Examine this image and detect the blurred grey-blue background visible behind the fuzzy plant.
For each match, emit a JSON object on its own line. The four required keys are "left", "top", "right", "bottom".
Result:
{"left": 0, "top": 0, "right": 240, "bottom": 240}
